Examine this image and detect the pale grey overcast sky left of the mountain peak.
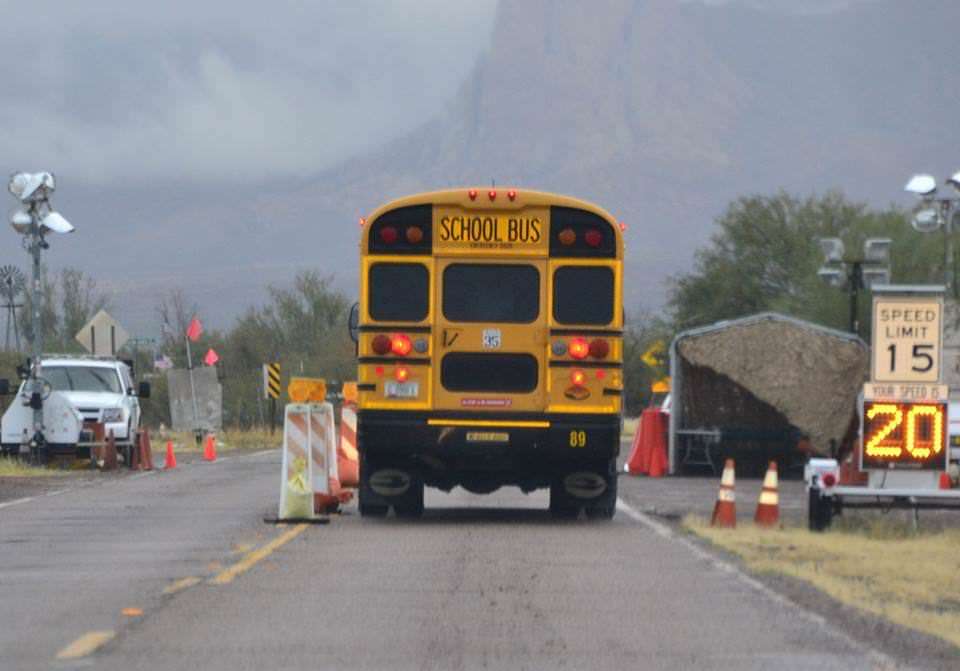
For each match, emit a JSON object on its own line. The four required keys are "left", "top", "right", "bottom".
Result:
{"left": 0, "top": 0, "right": 496, "bottom": 185}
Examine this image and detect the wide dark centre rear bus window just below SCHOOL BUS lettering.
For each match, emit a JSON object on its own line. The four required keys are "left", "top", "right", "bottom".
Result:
{"left": 443, "top": 263, "right": 540, "bottom": 324}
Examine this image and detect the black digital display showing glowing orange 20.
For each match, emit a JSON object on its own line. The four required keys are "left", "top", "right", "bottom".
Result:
{"left": 863, "top": 401, "right": 947, "bottom": 470}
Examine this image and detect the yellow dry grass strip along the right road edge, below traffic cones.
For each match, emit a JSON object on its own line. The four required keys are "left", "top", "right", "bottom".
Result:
{"left": 684, "top": 516, "right": 960, "bottom": 646}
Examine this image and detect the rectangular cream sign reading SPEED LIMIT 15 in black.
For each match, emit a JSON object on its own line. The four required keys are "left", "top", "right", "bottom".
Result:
{"left": 870, "top": 287, "right": 943, "bottom": 382}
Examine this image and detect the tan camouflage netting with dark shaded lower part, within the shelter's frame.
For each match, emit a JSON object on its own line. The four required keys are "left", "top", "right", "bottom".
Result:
{"left": 677, "top": 315, "right": 870, "bottom": 454}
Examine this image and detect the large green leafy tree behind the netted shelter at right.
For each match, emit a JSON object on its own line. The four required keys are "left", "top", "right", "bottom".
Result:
{"left": 668, "top": 192, "right": 943, "bottom": 337}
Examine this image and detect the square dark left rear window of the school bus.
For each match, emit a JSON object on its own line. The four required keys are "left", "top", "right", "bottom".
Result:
{"left": 368, "top": 263, "right": 430, "bottom": 322}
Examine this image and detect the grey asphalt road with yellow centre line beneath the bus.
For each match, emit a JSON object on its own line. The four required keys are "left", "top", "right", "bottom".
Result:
{"left": 0, "top": 444, "right": 885, "bottom": 671}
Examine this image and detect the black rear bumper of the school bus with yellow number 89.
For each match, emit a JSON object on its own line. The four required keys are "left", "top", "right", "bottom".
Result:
{"left": 357, "top": 411, "right": 620, "bottom": 489}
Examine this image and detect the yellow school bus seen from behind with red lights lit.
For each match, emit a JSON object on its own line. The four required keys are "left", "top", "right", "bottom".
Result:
{"left": 356, "top": 188, "right": 623, "bottom": 519}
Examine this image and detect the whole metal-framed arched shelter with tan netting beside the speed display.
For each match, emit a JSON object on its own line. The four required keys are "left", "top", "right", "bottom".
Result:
{"left": 669, "top": 312, "right": 869, "bottom": 476}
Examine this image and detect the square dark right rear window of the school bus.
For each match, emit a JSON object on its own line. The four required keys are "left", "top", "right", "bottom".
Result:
{"left": 553, "top": 266, "right": 613, "bottom": 325}
